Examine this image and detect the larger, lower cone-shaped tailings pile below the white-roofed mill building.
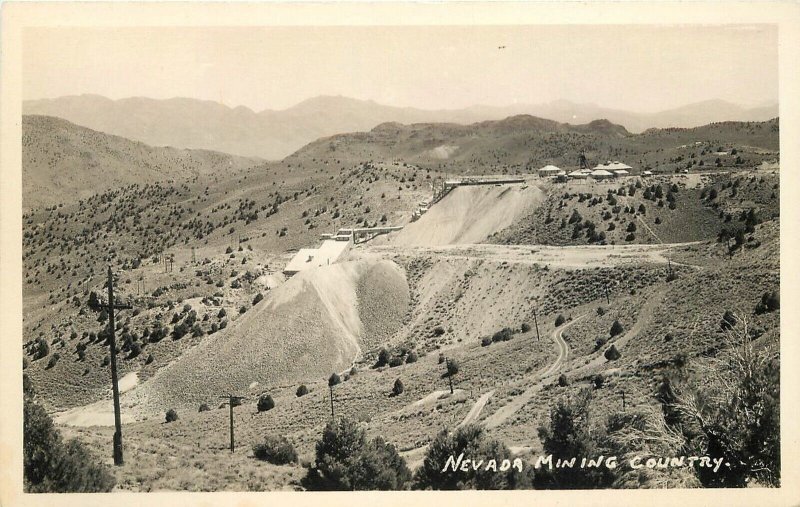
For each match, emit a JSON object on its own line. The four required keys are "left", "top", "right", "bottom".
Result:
{"left": 129, "top": 260, "right": 409, "bottom": 415}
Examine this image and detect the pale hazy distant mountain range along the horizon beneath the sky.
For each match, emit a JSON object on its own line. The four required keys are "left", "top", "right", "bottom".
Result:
{"left": 23, "top": 95, "right": 778, "bottom": 160}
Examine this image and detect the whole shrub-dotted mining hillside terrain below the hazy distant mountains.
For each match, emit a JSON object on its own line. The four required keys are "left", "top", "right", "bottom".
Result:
{"left": 21, "top": 112, "right": 780, "bottom": 491}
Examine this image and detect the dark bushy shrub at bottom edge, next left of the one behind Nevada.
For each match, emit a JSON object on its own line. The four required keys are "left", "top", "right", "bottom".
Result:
{"left": 302, "top": 417, "right": 411, "bottom": 491}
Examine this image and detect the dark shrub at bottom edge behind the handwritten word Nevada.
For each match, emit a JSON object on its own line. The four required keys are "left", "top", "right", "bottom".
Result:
{"left": 414, "top": 424, "right": 532, "bottom": 490}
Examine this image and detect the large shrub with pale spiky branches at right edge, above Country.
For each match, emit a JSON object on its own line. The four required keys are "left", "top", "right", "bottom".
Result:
{"left": 658, "top": 316, "right": 781, "bottom": 488}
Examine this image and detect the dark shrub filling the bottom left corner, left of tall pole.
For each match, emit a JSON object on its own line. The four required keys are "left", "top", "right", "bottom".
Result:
{"left": 23, "top": 399, "right": 116, "bottom": 493}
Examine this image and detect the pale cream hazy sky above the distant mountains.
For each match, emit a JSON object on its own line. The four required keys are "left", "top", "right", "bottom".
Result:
{"left": 23, "top": 25, "right": 778, "bottom": 111}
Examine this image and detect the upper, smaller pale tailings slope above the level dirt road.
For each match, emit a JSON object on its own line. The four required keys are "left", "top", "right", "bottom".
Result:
{"left": 391, "top": 184, "right": 544, "bottom": 246}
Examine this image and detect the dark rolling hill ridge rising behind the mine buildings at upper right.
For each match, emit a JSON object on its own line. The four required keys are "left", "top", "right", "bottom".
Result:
{"left": 286, "top": 115, "right": 780, "bottom": 174}
